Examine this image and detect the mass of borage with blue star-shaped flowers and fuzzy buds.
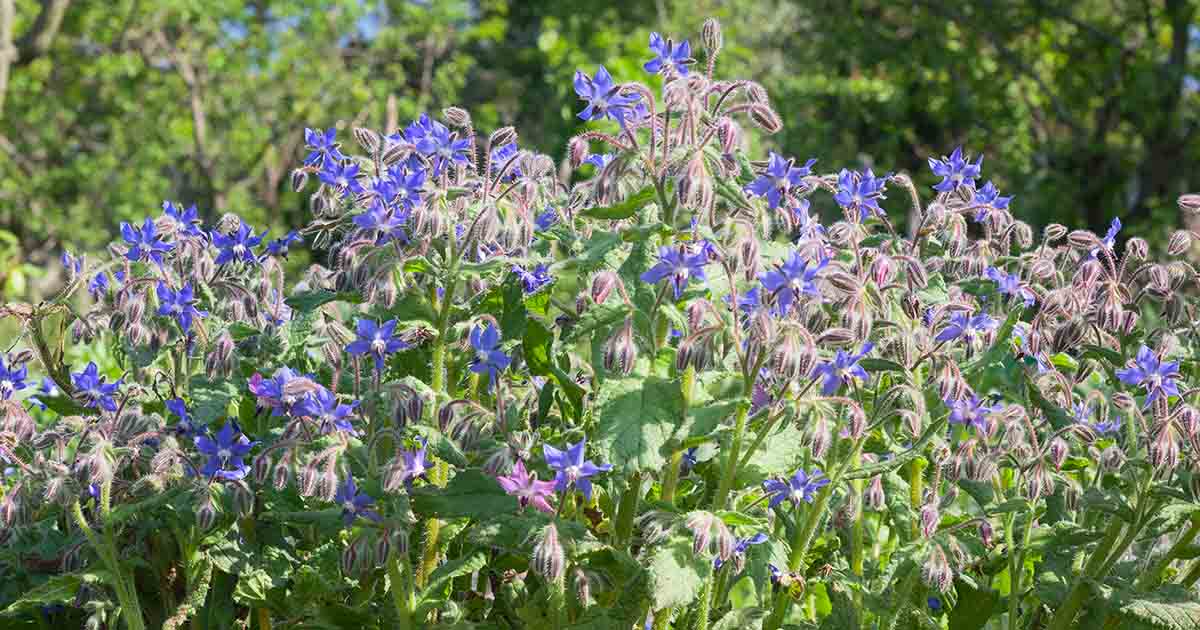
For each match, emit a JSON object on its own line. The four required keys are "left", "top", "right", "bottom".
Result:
{"left": 0, "top": 20, "right": 1200, "bottom": 630}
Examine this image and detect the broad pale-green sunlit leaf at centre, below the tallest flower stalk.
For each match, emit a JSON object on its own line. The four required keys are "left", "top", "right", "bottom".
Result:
{"left": 595, "top": 376, "right": 683, "bottom": 473}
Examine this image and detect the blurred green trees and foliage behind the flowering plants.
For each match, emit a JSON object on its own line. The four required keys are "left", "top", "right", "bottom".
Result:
{"left": 0, "top": 0, "right": 1200, "bottom": 299}
